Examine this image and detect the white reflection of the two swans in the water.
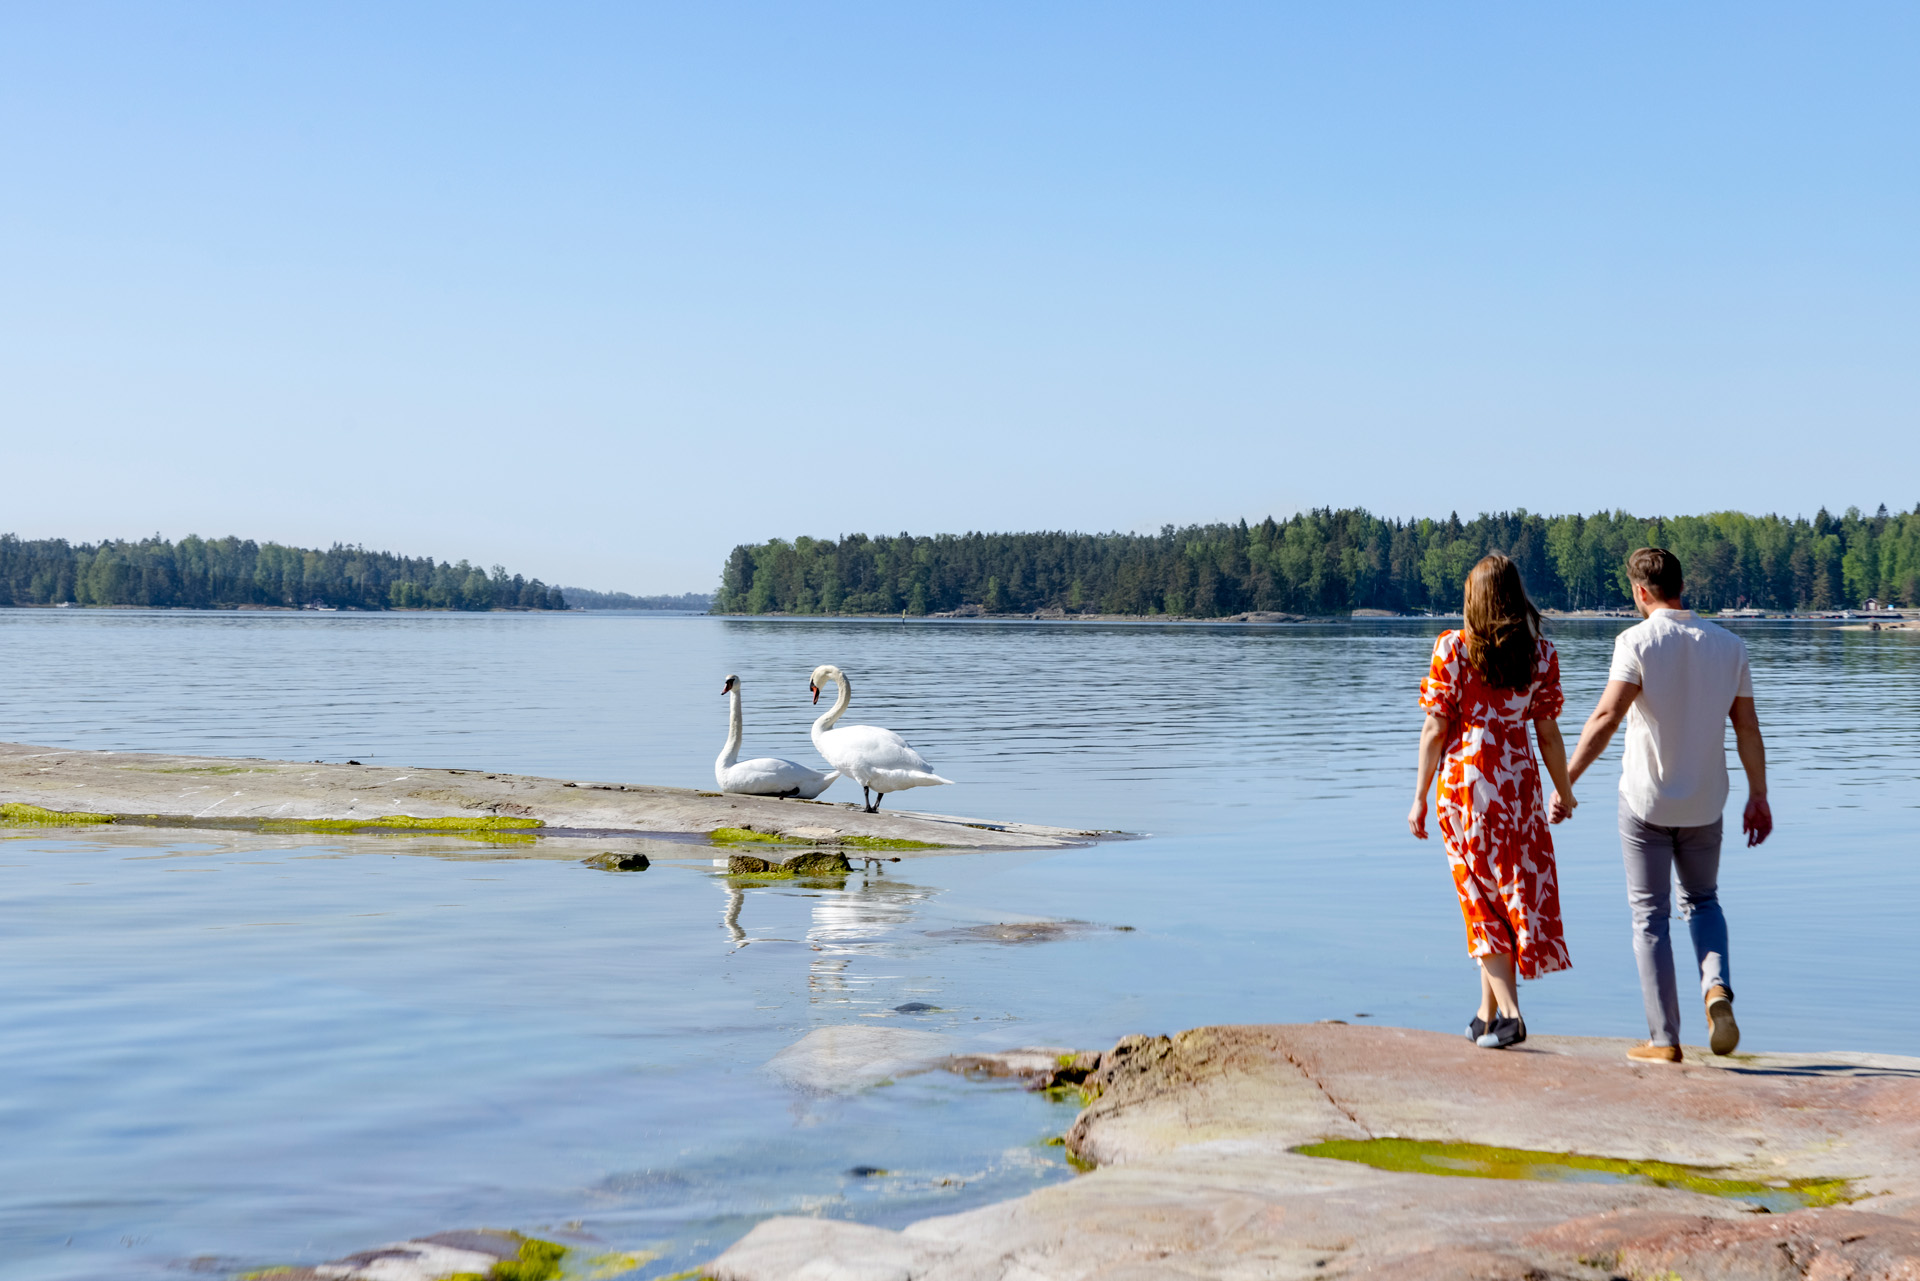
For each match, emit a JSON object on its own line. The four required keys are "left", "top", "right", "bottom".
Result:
{"left": 720, "top": 866, "right": 939, "bottom": 1004}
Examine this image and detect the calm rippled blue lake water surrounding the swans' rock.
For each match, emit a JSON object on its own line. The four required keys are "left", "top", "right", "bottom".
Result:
{"left": 0, "top": 611, "right": 1920, "bottom": 1277}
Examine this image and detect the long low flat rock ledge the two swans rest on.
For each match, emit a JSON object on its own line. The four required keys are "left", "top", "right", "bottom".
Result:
{"left": 0, "top": 743, "right": 1112, "bottom": 849}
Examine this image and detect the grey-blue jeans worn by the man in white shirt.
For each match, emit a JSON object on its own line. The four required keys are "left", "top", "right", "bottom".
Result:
{"left": 1620, "top": 801, "right": 1734, "bottom": 1045}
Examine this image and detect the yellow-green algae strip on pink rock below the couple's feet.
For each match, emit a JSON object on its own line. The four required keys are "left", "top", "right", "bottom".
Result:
{"left": 1294, "top": 1139, "right": 1853, "bottom": 1212}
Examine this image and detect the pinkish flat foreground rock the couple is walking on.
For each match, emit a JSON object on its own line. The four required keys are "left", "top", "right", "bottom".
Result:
{"left": 707, "top": 1024, "right": 1920, "bottom": 1281}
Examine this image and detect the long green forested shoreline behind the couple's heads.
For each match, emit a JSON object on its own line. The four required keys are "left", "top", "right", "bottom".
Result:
{"left": 714, "top": 507, "right": 1920, "bottom": 618}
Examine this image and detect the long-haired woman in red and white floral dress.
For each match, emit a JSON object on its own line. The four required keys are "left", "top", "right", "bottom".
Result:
{"left": 1407, "top": 553, "right": 1576, "bottom": 1049}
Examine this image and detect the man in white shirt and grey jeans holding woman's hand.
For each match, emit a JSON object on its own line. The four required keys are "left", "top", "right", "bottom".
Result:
{"left": 1555, "top": 547, "right": 1774, "bottom": 1064}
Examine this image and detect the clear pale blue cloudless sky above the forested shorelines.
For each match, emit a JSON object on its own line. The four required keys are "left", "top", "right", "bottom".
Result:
{"left": 0, "top": 2, "right": 1920, "bottom": 592}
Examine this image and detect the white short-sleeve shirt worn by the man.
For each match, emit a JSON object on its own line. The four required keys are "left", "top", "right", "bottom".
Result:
{"left": 1607, "top": 609, "right": 1753, "bottom": 828}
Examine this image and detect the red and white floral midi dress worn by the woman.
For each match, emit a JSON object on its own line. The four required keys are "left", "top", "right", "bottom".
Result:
{"left": 1421, "top": 632, "right": 1572, "bottom": 978}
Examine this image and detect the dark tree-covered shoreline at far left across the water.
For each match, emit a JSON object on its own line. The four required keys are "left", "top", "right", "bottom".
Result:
{"left": 0, "top": 534, "right": 566, "bottom": 609}
